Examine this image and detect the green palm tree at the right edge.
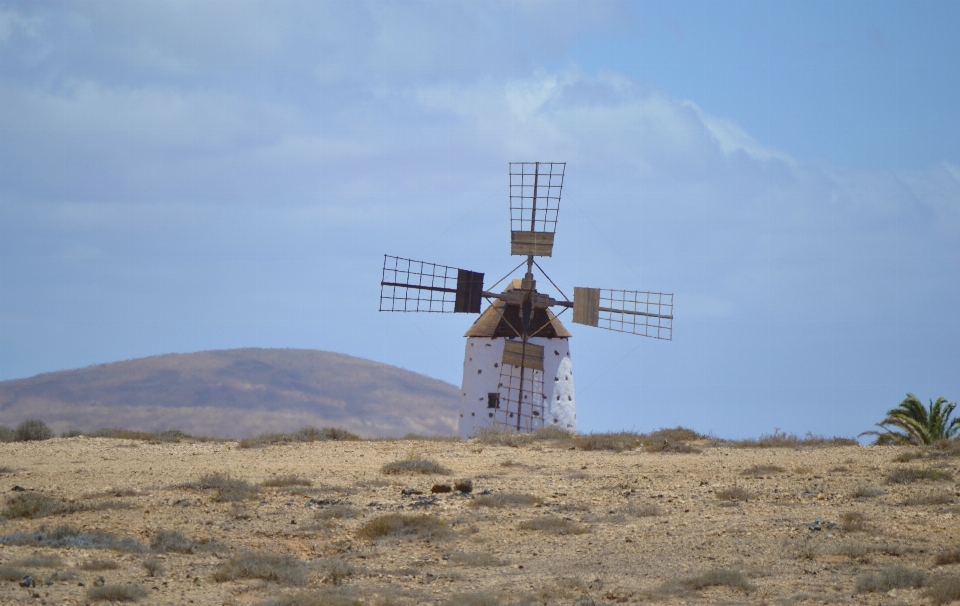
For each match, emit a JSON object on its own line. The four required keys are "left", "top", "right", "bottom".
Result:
{"left": 860, "top": 393, "right": 960, "bottom": 446}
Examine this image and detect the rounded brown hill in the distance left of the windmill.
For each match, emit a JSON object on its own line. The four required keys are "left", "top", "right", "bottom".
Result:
{"left": 0, "top": 348, "right": 460, "bottom": 438}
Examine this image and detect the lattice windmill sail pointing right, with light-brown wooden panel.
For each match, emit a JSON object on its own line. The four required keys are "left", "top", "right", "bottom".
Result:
{"left": 573, "top": 286, "right": 673, "bottom": 341}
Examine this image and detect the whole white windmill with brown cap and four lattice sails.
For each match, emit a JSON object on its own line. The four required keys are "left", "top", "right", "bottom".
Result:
{"left": 380, "top": 162, "right": 673, "bottom": 437}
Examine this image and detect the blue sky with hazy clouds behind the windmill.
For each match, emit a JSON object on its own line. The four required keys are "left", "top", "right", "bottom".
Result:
{"left": 0, "top": 0, "right": 960, "bottom": 438}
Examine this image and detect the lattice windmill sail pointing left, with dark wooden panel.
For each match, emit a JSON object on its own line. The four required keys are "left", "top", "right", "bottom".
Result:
{"left": 380, "top": 255, "right": 483, "bottom": 314}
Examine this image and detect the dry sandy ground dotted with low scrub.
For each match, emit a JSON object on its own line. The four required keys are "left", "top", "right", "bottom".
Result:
{"left": 0, "top": 437, "right": 960, "bottom": 606}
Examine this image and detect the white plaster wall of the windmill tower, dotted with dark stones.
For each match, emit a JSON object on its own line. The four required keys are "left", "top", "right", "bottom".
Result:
{"left": 459, "top": 337, "right": 577, "bottom": 438}
